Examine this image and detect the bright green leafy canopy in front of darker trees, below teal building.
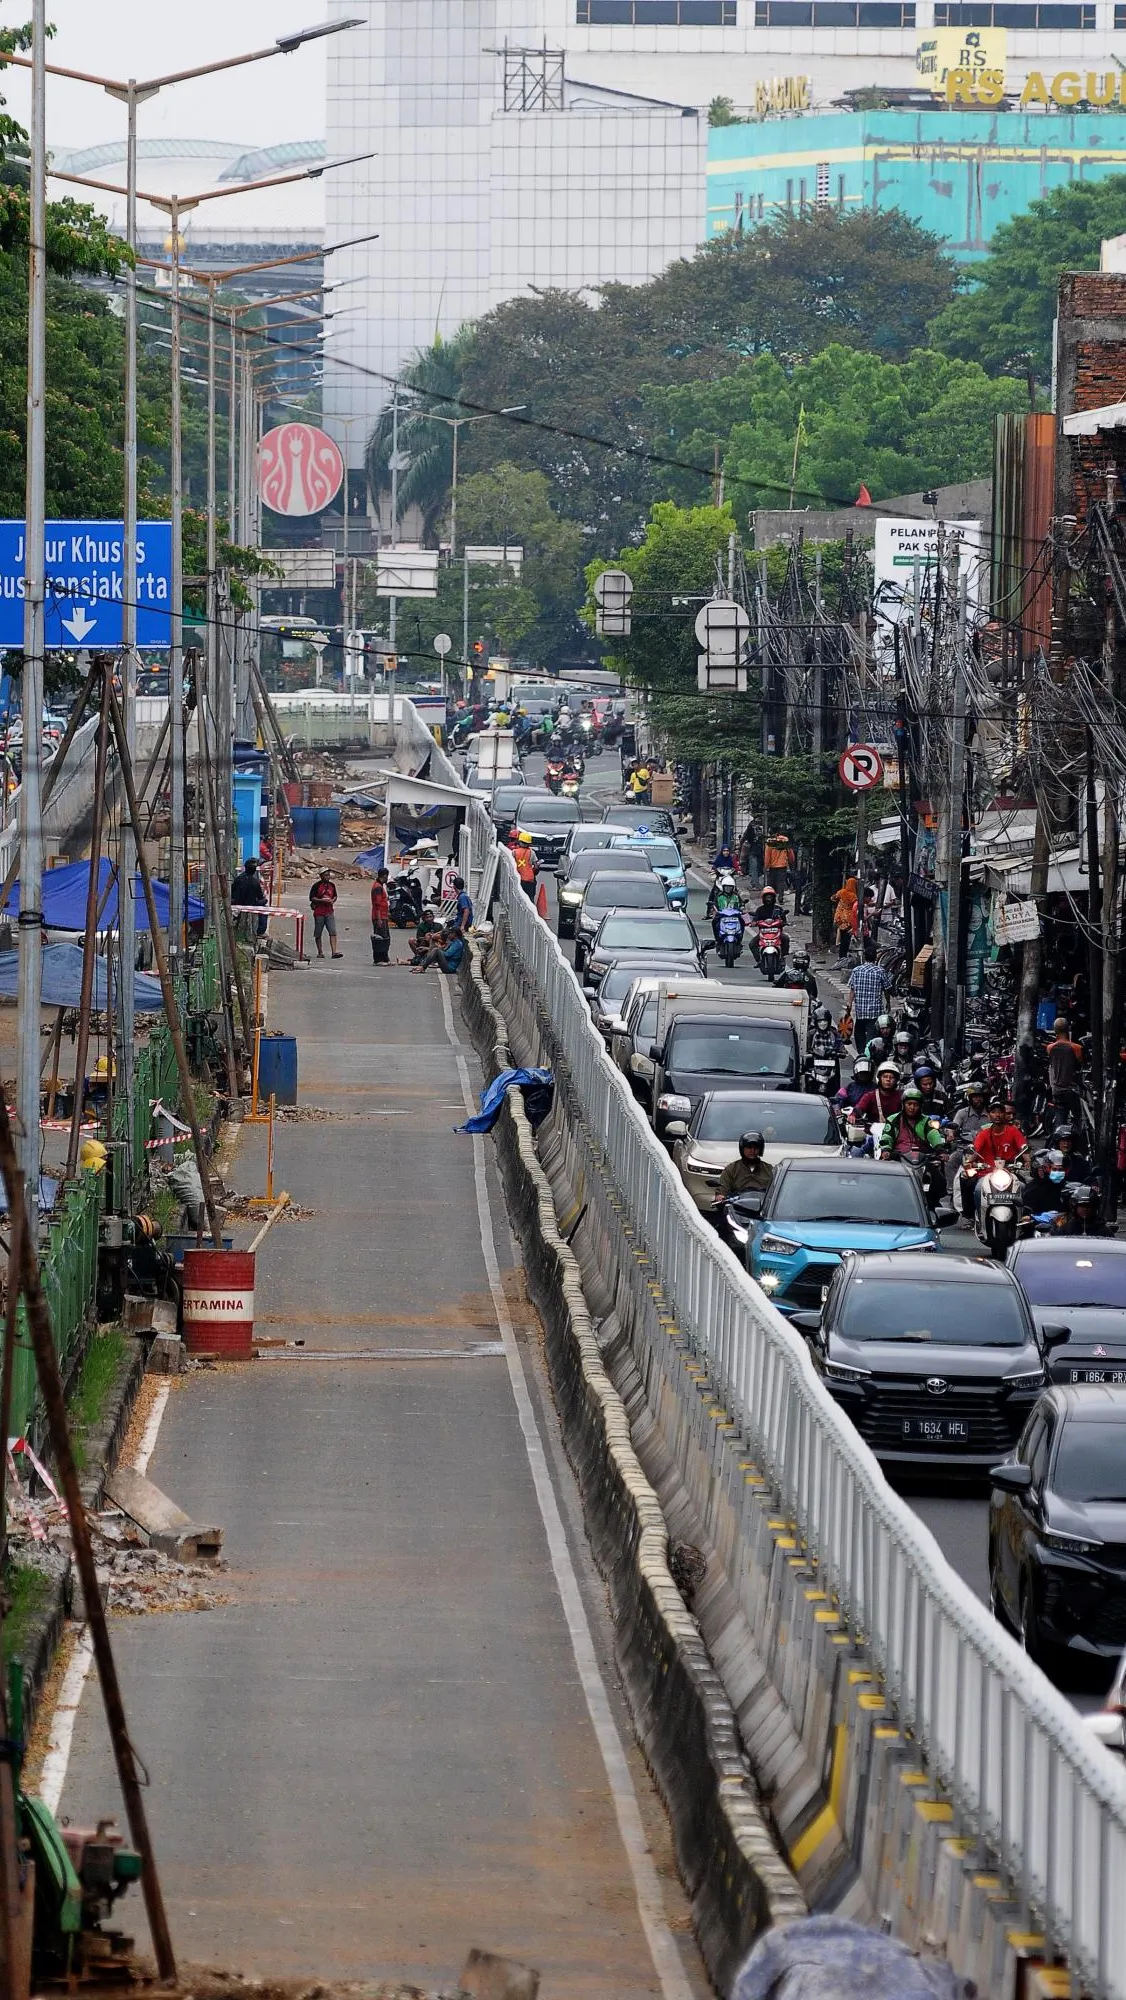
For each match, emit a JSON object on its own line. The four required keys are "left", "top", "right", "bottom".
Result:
{"left": 644, "top": 346, "right": 1024, "bottom": 516}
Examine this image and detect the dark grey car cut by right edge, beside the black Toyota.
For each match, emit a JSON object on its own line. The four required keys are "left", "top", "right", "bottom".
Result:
{"left": 1008, "top": 1236, "right": 1126, "bottom": 1382}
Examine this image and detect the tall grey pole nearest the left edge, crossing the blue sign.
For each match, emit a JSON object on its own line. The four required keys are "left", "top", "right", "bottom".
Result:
{"left": 18, "top": 0, "right": 46, "bottom": 1216}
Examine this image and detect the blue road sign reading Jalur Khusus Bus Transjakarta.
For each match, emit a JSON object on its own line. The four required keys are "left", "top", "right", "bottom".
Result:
{"left": 0, "top": 520, "right": 172, "bottom": 652}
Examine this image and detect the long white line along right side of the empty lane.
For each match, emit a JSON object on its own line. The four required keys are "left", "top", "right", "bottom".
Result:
{"left": 438, "top": 976, "right": 692, "bottom": 2000}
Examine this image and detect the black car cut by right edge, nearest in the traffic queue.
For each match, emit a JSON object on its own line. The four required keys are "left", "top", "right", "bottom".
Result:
{"left": 990, "top": 1384, "right": 1126, "bottom": 1666}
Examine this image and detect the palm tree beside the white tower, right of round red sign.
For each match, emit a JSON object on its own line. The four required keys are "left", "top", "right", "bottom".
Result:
{"left": 366, "top": 326, "right": 472, "bottom": 540}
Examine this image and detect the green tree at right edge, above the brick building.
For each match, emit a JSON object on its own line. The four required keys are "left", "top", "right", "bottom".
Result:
{"left": 932, "top": 174, "right": 1126, "bottom": 402}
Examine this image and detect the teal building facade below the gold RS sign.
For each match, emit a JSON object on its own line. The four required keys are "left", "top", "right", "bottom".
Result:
{"left": 706, "top": 106, "right": 1126, "bottom": 262}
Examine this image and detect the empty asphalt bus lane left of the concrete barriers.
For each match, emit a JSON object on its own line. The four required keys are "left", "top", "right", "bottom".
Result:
{"left": 62, "top": 860, "right": 710, "bottom": 2000}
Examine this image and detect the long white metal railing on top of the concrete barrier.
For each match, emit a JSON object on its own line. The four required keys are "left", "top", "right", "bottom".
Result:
{"left": 490, "top": 806, "right": 1126, "bottom": 2000}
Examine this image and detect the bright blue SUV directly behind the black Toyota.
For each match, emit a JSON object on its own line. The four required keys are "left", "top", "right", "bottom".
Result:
{"left": 748, "top": 1158, "right": 938, "bottom": 1312}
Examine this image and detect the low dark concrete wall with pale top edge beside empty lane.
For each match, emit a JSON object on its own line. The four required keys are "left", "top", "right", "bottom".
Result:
{"left": 462, "top": 954, "right": 806, "bottom": 1992}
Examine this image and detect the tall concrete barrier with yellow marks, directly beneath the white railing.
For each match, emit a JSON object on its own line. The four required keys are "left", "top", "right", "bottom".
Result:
{"left": 470, "top": 918, "right": 1080, "bottom": 2000}
